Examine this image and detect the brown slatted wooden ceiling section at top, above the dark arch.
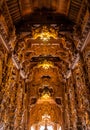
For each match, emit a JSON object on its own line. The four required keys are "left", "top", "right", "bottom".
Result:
{"left": 6, "top": 0, "right": 89, "bottom": 23}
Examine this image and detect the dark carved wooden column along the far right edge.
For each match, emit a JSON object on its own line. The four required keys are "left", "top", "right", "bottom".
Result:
{"left": 80, "top": 57, "right": 90, "bottom": 129}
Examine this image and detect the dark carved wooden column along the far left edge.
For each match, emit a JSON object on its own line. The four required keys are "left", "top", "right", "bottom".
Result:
{"left": 0, "top": 46, "right": 8, "bottom": 123}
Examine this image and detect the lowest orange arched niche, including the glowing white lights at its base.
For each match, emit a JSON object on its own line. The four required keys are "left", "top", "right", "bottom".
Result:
{"left": 28, "top": 99, "right": 62, "bottom": 130}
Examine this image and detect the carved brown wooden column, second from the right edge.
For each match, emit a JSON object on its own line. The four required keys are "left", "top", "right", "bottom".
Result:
{"left": 74, "top": 62, "right": 89, "bottom": 130}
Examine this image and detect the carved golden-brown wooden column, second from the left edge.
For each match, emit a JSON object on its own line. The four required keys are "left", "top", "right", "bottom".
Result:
{"left": 1, "top": 58, "right": 14, "bottom": 129}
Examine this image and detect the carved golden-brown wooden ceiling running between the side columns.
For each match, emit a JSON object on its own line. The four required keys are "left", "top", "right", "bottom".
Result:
{"left": 0, "top": 0, "right": 90, "bottom": 129}
